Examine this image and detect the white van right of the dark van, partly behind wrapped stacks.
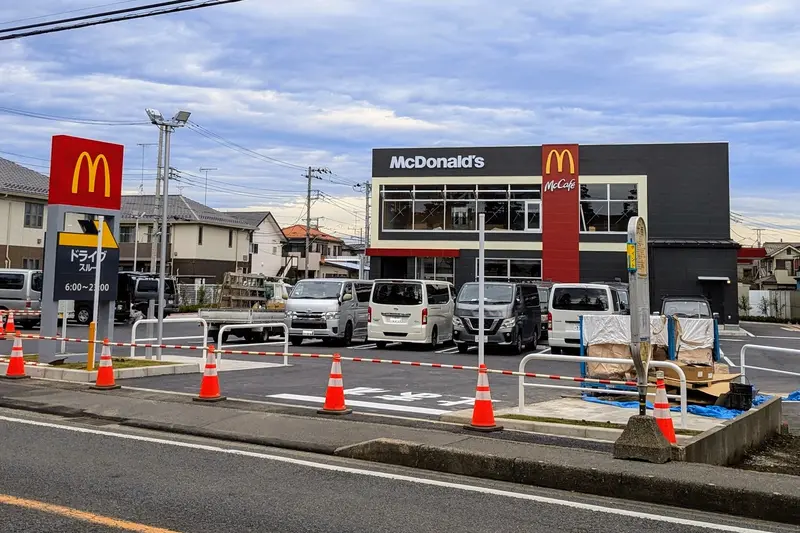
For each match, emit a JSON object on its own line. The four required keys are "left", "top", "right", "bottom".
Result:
{"left": 547, "top": 283, "right": 620, "bottom": 354}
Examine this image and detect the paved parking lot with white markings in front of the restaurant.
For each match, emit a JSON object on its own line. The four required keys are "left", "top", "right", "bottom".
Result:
{"left": 0, "top": 318, "right": 800, "bottom": 423}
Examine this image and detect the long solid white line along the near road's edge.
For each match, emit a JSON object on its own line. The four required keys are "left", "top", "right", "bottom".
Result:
{"left": 0, "top": 416, "right": 770, "bottom": 533}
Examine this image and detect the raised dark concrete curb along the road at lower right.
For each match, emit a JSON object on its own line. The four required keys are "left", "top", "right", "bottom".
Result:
{"left": 335, "top": 439, "right": 800, "bottom": 524}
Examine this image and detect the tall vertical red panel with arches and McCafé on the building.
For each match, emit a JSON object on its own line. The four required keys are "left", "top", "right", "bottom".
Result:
{"left": 542, "top": 144, "right": 581, "bottom": 283}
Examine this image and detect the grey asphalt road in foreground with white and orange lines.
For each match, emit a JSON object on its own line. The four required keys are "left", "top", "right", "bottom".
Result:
{"left": 0, "top": 411, "right": 796, "bottom": 533}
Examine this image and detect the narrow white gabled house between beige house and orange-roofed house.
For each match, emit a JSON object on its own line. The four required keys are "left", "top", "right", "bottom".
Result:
{"left": 224, "top": 210, "right": 288, "bottom": 276}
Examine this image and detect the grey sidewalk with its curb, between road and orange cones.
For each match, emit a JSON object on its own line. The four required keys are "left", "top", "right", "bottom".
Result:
{"left": 0, "top": 380, "right": 800, "bottom": 524}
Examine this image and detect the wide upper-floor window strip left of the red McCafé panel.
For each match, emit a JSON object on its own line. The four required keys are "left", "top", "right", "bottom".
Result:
{"left": 381, "top": 184, "right": 542, "bottom": 231}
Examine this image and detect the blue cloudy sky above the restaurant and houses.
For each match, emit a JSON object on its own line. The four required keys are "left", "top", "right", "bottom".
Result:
{"left": 0, "top": 0, "right": 800, "bottom": 244}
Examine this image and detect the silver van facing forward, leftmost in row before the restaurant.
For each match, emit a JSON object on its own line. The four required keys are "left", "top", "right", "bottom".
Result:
{"left": 286, "top": 278, "right": 372, "bottom": 346}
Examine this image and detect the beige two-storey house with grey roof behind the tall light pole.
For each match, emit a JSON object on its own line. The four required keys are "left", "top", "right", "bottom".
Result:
{"left": 119, "top": 194, "right": 256, "bottom": 283}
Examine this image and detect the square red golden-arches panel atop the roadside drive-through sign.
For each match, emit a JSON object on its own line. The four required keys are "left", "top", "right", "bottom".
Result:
{"left": 47, "top": 135, "right": 125, "bottom": 210}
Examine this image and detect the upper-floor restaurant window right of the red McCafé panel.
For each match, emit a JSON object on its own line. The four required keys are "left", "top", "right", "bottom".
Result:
{"left": 580, "top": 183, "right": 639, "bottom": 233}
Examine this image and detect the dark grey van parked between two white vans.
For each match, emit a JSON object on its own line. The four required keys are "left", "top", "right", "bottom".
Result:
{"left": 453, "top": 282, "right": 542, "bottom": 355}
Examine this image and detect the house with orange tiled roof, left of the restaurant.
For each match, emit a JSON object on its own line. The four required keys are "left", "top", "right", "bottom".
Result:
{"left": 283, "top": 224, "right": 350, "bottom": 280}
